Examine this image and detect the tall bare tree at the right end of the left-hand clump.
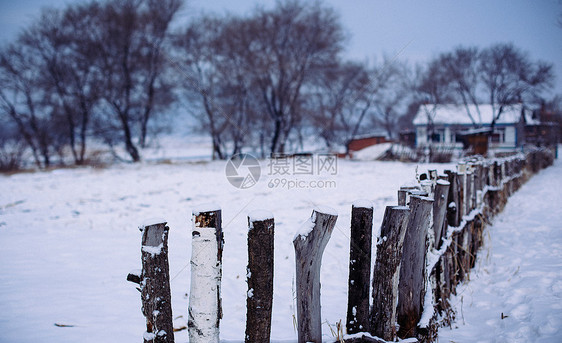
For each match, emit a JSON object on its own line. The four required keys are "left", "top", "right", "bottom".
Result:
{"left": 92, "top": 0, "right": 181, "bottom": 162}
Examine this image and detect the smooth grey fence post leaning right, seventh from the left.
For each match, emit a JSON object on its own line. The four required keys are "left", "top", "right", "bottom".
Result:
{"left": 397, "top": 196, "right": 433, "bottom": 338}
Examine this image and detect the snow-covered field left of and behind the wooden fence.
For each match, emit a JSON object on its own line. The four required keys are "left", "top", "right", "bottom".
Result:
{"left": 0, "top": 148, "right": 444, "bottom": 343}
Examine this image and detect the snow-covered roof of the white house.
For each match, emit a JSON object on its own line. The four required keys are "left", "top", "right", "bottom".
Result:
{"left": 414, "top": 104, "right": 537, "bottom": 125}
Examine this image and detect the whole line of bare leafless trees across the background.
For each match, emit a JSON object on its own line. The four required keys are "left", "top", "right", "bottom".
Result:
{"left": 0, "top": 0, "right": 561, "bottom": 169}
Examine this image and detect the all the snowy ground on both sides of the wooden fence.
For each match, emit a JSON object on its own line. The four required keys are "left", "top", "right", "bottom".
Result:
{"left": 0, "top": 146, "right": 562, "bottom": 343}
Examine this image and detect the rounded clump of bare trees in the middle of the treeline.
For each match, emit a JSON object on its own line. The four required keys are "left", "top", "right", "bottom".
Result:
{"left": 174, "top": 1, "right": 344, "bottom": 158}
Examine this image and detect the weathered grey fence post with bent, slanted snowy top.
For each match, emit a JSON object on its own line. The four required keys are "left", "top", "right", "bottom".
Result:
{"left": 293, "top": 207, "right": 338, "bottom": 343}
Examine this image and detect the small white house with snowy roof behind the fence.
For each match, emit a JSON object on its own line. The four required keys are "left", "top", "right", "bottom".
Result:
{"left": 414, "top": 105, "right": 538, "bottom": 149}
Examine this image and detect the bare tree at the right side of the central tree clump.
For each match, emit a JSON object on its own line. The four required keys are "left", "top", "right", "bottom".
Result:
{"left": 234, "top": 1, "right": 344, "bottom": 153}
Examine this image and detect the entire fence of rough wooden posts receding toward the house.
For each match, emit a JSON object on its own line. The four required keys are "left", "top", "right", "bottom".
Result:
{"left": 127, "top": 149, "right": 555, "bottom": 343}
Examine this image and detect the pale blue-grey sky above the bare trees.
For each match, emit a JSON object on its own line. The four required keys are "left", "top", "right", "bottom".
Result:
{"left": 0, "top": 0, "right": 562, "bottom": 94}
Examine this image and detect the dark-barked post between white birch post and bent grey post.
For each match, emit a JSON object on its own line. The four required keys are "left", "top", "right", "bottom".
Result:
{"left": 245, "top": 211, "right": 275, "bottom": 343}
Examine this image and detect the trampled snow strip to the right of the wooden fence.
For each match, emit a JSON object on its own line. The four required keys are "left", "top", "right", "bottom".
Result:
{"left": 439, "top": 160, "right": 562, "bottom": 343}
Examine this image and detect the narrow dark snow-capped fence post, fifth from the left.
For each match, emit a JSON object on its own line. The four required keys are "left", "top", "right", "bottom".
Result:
{"left": 346, "top": 201, "right": 373, "bottom": 334}
